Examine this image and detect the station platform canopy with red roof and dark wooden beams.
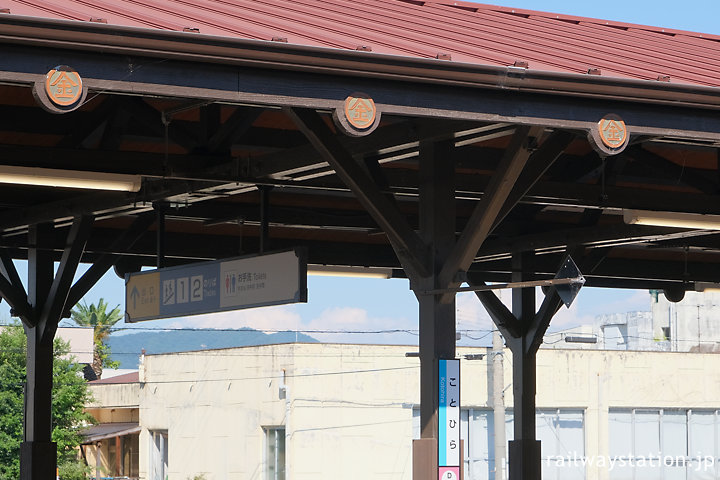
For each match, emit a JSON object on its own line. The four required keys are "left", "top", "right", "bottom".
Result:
{"left": 0, "top": 0, "right": 720, "bottom": 294}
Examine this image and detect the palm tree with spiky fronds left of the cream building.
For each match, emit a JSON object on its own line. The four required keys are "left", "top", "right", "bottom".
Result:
{"left": 70, "top": 298, "right": 122, "bottom": 378}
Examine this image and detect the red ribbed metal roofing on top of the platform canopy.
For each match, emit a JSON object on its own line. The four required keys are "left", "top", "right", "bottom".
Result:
{"left": 0, "top": 0, "right": 720, "bottom": 86}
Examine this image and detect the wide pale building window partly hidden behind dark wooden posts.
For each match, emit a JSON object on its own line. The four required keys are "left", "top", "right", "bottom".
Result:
{"left": 413, "top": 408, "right": 585, "bottom": 480}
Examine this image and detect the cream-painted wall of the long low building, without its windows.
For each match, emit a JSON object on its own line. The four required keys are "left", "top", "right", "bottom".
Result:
{"left": 90, "top": 344, "right": 720, "bottom": 480}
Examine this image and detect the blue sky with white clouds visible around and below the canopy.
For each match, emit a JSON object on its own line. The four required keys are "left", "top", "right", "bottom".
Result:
{"left": 0, "top": 0, "right": 708, "bottom": 344}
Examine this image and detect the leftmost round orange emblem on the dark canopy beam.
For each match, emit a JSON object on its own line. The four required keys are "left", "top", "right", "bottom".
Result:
{"left": 33, "top": 65, "right": 87, "bottom": 113}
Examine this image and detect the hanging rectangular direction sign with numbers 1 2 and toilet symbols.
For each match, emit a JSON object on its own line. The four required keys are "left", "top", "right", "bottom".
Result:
{"left": 125, "top": 249, "right": 307, "bottom": 323}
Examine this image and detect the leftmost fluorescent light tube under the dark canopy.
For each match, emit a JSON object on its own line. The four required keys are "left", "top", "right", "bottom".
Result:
{"left": 0, "top": 165, "right": 142, "bottom": 192}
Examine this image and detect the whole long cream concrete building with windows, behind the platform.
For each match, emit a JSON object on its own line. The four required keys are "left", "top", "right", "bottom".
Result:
{"left": 86, "top": 344, "right": 720, "bottom": 480}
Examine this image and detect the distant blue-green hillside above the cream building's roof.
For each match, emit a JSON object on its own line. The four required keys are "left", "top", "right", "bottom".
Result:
{"left": 107, "top": 328, "right": 317, "bottom": 368}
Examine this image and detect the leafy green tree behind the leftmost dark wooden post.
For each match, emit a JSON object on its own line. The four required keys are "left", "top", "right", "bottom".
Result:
{"left": 0, "top": 324, "right": 93, "bottom": 480}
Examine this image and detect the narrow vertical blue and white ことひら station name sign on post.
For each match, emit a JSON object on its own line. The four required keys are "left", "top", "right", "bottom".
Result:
{"left": 438, "top": 359, "right": 461, "bottom": 480}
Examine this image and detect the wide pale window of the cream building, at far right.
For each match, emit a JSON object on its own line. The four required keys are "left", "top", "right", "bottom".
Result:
{"left": 609, "top": 409, "right": 720, "bottom": 480}
